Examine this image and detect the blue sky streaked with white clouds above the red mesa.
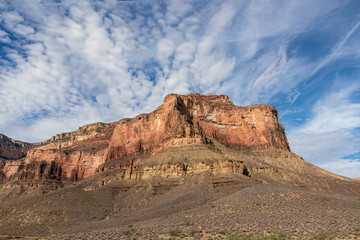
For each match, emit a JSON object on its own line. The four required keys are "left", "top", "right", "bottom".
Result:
{"left": 0, "top": 0, "right": 360, "bottom": 177}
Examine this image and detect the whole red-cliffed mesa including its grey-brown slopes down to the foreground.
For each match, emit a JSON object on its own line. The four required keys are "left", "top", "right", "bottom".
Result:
{"left": 0, "top": 94, "right": 360, "bottom": 239}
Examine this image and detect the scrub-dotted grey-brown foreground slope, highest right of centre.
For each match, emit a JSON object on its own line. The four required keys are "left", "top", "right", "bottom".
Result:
{"left": 44, "top": 186, "right": 360, "bottom": 239}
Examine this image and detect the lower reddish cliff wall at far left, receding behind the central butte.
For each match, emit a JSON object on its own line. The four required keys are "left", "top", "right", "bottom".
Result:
{"left": 0, "top": 123, "right": 113, "bottom": 181}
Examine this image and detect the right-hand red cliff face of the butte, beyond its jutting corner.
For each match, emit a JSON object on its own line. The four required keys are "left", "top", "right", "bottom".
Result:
{"left": 174, "top": 94, "right": 290, "bottom": 151}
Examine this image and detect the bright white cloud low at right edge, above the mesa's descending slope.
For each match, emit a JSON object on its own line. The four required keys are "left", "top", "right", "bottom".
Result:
{"left": 288, "top": 83, "right": 360, "bottom": 177}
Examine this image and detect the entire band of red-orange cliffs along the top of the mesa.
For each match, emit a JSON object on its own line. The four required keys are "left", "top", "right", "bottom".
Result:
{"left": 3, "top": 94, "right": 290, "bottom": 181}
